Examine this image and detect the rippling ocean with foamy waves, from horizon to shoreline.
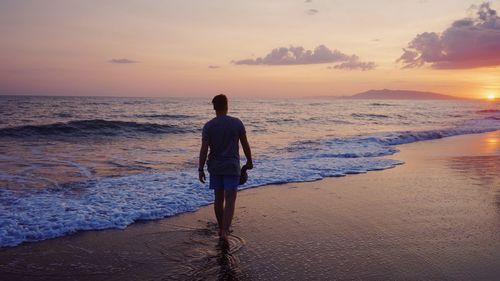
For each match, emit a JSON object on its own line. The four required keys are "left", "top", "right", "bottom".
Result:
{"left": 0, "top": 96, "right": 500, "bottom": 247}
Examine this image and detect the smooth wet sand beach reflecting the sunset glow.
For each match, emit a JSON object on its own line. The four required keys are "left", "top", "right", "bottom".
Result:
{"left": 0, "top": 131, "right": 500, "bottom": 280}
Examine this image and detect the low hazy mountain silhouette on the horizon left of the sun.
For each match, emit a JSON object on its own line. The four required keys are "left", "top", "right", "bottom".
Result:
{"left": 342, "top": 89, "right": 462, "bottom": 100}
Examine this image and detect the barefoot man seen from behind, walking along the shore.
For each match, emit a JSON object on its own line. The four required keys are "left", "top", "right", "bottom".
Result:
{"left": 198, "top": 95, "right": 253, "bottom": 240}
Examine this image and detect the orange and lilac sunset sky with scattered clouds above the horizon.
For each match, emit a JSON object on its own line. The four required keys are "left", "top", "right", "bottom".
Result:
{"left": 0, "top": 0, "right": 500, "bottom": 98}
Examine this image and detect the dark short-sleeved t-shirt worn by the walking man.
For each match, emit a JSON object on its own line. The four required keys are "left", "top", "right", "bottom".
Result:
{"left": 202, "top": 115, "right": 246, "bottom": 176}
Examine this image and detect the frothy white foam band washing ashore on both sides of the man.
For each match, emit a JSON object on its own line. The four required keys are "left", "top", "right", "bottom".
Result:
{"left": 0, "top": 157, "right": 399, "bottom": 246}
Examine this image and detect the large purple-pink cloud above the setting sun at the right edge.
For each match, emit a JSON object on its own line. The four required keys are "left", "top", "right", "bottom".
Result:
{"left": 397, "top": 2, "right": 500, "bottom": 69}
